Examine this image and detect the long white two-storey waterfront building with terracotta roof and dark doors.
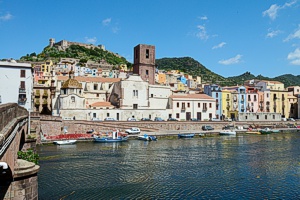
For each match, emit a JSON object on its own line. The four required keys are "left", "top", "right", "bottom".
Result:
{"left": 169, "top": 94, "right": 216, "bottom": 121}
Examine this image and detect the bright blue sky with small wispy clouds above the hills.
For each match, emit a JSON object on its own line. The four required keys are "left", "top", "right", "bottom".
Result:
{"left": 0, "top": 0, "right": 300, "bottom": 77}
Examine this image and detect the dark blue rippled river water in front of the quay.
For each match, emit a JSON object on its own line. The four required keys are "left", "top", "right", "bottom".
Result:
{"left": 38, "top": 133, "right": 300, "bottom": 199}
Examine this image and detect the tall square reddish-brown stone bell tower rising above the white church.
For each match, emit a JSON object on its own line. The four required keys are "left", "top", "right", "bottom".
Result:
{"left": 133, "top": 44, "right": 155, "bottom": 85}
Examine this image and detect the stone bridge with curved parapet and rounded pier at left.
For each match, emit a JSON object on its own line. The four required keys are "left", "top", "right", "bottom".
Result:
{"left": 0, "top": 103, "right": 39, "bottom": 200}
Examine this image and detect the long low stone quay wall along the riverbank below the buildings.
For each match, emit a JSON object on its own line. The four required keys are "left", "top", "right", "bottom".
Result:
{"left": 32, "top": 116, "right": 295, "bottom": 141}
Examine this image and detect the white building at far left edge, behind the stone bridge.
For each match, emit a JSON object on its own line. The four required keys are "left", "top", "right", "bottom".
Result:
{"left": 0, "top": 61, "right": 33, "bottom": 110}
